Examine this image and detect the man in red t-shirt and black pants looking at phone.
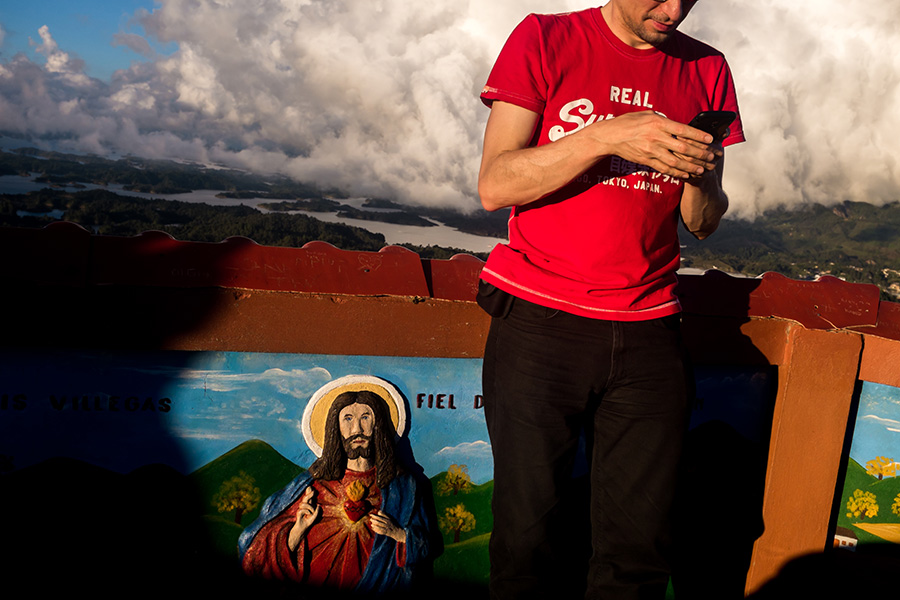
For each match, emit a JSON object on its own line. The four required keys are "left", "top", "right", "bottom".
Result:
{"left": 478, "top": 0, "right": 744, "bottom": 600}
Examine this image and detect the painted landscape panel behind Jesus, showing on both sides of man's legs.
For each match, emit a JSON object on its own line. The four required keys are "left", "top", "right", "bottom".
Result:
{"left": 0, "top": 351, "right": 772, "bottom": 586}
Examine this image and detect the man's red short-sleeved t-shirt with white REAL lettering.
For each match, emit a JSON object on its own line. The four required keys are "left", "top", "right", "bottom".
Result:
{"left": 481, "top": 8, "right": 744, "bottom": 321}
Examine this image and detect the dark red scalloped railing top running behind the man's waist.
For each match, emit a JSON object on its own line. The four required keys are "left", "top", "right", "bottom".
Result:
{"left": 0, "top": 223, "right": 900, "bottom": 339}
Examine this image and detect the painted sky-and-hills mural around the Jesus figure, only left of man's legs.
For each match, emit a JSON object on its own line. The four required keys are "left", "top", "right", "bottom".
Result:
{"left": 0, "top": 352, "right": 493, "bottom": 582}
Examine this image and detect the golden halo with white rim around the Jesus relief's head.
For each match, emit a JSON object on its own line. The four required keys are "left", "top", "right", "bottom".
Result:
{"left": 301, "top": 375, "right": 406, "bottom": 456}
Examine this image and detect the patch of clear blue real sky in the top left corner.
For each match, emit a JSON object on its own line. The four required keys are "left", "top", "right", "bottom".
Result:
{"left": 0, "top": 0, "right": 176, "bottom": 80}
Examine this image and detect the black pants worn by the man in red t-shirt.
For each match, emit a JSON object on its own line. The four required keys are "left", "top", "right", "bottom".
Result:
{"left": 483, "top": 299, "right": 689, "bottom": 600}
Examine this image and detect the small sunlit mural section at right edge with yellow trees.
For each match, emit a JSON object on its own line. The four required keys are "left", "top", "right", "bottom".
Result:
{"left": 834, "top": 381, "right": 900, "bottom": 548}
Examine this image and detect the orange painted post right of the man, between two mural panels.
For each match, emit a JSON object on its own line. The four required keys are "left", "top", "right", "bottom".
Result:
{"left": 746, "top": 325, "right": 862, "bottom": 593}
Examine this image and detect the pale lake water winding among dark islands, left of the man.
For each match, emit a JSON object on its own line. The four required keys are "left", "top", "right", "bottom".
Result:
{"left": 0, "top": 175, "right": 506, "bottom": 252}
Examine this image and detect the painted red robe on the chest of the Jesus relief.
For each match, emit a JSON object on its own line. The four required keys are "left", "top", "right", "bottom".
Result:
{"left": 243, "top": 469, "right": 405, "bottom": 590}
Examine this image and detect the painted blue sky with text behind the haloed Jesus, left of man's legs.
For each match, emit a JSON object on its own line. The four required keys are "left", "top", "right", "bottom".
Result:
{"left": 0, "top": 352, "right": 493, "bottom": 483}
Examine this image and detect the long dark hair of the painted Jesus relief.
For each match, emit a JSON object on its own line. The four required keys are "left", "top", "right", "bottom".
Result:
{"left": 309, "top": 390, "right": 402, "bottom": 489}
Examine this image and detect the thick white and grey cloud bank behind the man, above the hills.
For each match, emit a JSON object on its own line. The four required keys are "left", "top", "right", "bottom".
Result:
{"left": 0, "top": 0, "right": 900, "bottom": 217}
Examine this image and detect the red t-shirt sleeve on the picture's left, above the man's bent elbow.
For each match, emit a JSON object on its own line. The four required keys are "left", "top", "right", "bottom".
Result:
{"left": 481, "top": 15, "right": 547, "bottom": 114}
